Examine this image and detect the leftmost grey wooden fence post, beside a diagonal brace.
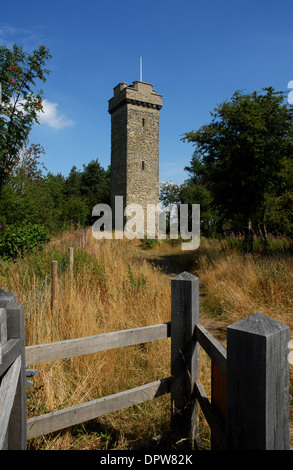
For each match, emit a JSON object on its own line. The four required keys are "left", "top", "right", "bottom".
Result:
{"left": 6, "top": 302, "right": 27, "bottom": 450}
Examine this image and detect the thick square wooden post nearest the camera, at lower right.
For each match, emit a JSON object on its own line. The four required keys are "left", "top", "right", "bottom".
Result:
{"left": 226, "top": 313, "right": 289, "bottom": 450}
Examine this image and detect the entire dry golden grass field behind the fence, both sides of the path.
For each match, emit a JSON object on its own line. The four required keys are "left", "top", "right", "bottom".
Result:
{"left": 0, "top": 231, "right": 293, "bottom": 449}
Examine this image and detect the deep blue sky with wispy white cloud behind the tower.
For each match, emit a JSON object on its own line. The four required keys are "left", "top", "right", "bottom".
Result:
{"left": 0, "top": 0, "right": 293, "bottom": 183}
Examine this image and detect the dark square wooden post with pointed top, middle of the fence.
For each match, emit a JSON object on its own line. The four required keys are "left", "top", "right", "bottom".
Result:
{"left": 171, "top": 272, "right": 199, "bottom": 439}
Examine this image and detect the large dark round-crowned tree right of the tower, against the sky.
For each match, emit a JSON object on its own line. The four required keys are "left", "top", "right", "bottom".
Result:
{"left": 182, "top": 87, "right": 293, "bottom": 244}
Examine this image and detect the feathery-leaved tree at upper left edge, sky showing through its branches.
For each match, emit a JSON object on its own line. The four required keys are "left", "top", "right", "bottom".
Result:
{"left": 0, "top": 45, "right": 51, "bottom": 188}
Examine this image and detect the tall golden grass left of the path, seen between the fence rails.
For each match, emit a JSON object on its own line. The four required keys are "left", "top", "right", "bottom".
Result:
{"left": 0, "top": 232, "right": 170, "bottom": 449}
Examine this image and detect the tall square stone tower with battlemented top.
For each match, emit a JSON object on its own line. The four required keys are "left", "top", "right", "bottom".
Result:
{"left": 109, "top": 81, "right": 162, "bottom": 235}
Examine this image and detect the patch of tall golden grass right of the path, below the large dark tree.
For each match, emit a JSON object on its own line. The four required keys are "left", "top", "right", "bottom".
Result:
{"left": 193, "top": 239, "right": 293, "bottom": 327}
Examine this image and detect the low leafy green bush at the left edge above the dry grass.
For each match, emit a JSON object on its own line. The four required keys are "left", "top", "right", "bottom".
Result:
{"left": 0, "top": 223, "right": 50, "bottom": 258}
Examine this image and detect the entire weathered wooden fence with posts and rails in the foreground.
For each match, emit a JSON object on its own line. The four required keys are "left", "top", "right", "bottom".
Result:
{"left": 0, "top": 272, "right": 289, "bottom": 450}
